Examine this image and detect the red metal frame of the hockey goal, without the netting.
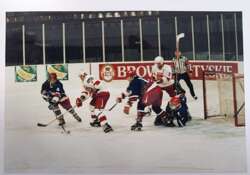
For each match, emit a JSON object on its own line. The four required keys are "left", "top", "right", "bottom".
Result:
{"left": 202, "top": 71, "right": 245, "bottom": 127}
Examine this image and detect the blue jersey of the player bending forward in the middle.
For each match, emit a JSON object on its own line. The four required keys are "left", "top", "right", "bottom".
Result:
{"left": 127, "top": 76, "right": 148, "bottom": 98}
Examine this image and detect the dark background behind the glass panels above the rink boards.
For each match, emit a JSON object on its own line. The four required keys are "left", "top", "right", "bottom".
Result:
{"left": 6, "top": 11, "right": 243, "bottom": 66}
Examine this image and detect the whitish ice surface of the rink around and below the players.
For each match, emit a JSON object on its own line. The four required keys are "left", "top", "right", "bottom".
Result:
{"left": 5, "top": 66, "right": 246, "bottom": 174}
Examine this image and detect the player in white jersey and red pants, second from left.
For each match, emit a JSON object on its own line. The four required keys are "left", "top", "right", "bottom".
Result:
{"left": 76, "top": 72, "right": 113, "bottom": 133}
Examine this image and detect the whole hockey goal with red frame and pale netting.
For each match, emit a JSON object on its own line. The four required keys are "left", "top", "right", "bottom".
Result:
{"left": 203, "top": 71, "right": 245, "bottom": 126}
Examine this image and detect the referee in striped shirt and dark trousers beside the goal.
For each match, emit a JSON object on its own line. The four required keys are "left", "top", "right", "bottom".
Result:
{"left": 173, "top": 50, "right": 197, "bottom": 100}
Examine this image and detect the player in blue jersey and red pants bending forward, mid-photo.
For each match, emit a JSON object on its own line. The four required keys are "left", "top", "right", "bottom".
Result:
{"left": 117, "top": 71, "right": 172, "bottom": 131}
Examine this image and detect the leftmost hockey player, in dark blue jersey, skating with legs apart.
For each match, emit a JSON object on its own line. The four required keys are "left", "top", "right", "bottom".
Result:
{"left": 41, "top": 73, "right": 82, "bottom": 126}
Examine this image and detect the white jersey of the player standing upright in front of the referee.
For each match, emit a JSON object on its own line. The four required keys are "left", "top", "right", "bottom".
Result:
{"left": 152, "top": 64, "right": 174, "bottom": 87}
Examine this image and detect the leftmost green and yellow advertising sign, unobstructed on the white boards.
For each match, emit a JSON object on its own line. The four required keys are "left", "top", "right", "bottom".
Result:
{"left": 15, "top": 65, "right": 37, "bottom": 82}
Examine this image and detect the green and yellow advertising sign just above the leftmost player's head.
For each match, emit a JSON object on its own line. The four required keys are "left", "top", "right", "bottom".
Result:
{"left": 46, "top": 64, "right": 69, "bottom": 80}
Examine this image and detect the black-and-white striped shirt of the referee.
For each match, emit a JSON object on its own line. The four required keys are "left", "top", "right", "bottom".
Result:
{"left": 173, "top": 56, "right": 188, "bottom": 74}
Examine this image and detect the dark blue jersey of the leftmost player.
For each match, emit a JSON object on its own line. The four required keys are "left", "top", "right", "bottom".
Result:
{"left": 41, "top": 80, "right": 66, "bottom": 97}
